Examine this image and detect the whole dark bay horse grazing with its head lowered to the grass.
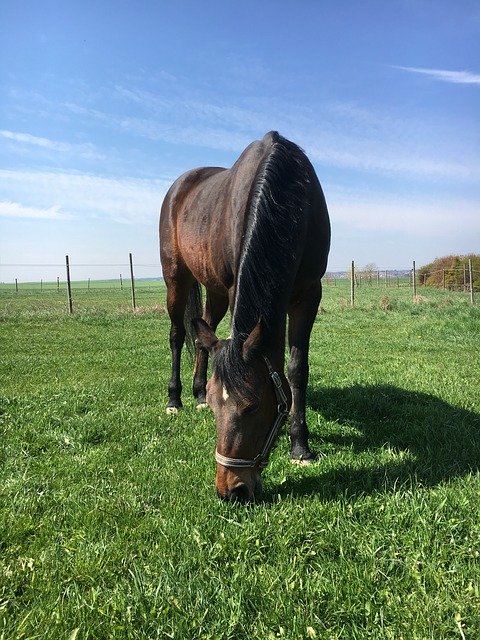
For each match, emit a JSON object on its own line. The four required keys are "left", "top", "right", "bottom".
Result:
{"left": 159, "top": 131, "right": 330, "bottom": 503}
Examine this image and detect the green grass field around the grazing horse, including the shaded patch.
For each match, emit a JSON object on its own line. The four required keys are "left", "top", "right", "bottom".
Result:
{"left": 0, "top": 283, "right": 480, "bottom": 640}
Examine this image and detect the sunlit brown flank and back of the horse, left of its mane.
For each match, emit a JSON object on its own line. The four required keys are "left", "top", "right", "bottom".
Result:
{"left": 160, "top": 136, "right": 274, "bottom": 295}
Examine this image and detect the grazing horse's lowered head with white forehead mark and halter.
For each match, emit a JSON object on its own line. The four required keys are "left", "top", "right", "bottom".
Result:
{"left": 194, "top": 320, "right": 291, "bottom": 502}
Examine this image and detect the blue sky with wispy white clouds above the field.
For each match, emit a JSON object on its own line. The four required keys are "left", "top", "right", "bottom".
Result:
{"left": 0, "top": 0, "right": 480, "bottom": 282}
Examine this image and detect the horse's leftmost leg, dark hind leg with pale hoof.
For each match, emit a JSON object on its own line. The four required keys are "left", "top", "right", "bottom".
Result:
{"left": 167, "top": 280, "right": 191, "bottom": 413}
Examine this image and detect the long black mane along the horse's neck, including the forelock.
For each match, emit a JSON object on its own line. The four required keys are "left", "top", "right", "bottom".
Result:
{"left": 214, "top": 132, "right": 312, "bottom": 399}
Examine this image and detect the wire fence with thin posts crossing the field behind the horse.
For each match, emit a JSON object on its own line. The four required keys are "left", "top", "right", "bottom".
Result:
{"left": 0, "top": 254, "right": 480, "bottom": 313}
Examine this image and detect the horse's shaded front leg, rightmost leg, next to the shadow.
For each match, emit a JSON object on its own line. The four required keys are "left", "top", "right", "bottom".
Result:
{"left": 288, "top": 281, "right": 322, "bottom": 464}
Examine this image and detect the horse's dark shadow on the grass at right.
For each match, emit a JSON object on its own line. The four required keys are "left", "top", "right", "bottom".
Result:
{"left": 275, "top": 385, "right": 480, "bottom": 500}
